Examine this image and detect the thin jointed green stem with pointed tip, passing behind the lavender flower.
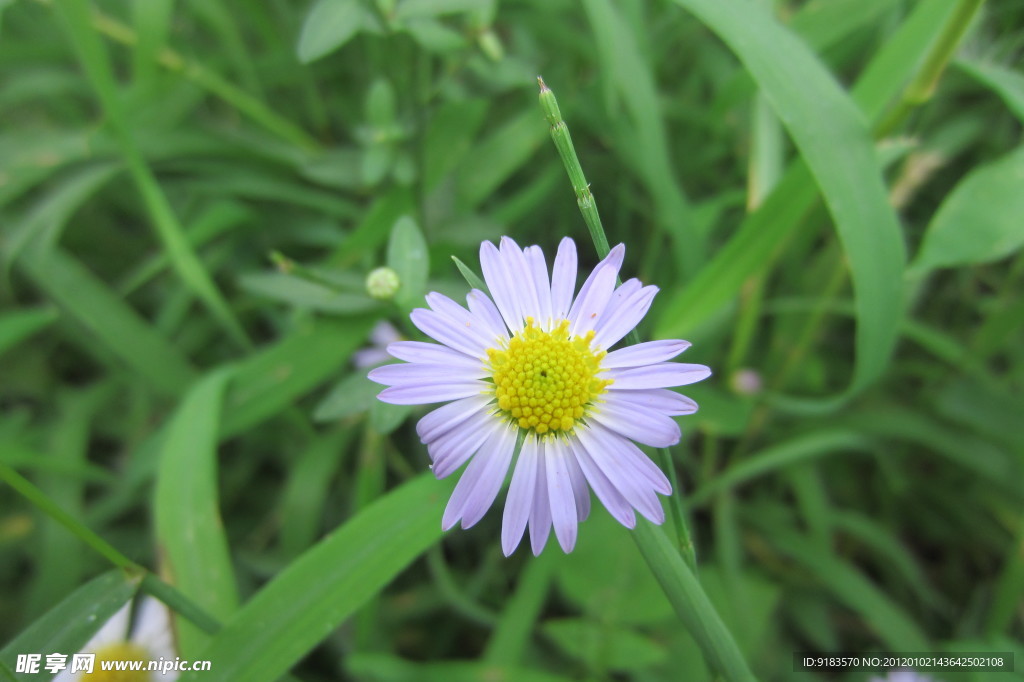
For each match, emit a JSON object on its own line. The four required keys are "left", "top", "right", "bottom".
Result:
{"left": 537, "top": 76, "right": 696, "bottom": 568}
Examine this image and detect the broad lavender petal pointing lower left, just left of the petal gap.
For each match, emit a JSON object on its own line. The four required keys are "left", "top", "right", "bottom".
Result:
{"left": 441, "top": 425, "right": 515, "bottom": 530}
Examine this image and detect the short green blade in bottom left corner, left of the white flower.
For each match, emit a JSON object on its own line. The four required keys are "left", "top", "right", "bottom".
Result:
{"left": 0, "top": 569, "right": 138, "bottom": 682}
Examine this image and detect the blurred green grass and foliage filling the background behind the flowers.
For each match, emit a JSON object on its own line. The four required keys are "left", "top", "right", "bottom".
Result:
{"left": 0, "top": 0, "right": 1024, "bottom": 682}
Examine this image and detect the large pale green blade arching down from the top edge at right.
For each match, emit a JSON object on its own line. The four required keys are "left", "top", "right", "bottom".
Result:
{"left": 677, "top": 0, "right": 905, "bottom": 409}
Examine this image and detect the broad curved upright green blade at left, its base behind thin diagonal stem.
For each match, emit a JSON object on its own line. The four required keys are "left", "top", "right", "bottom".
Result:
{"left": 154, "top": 370, "right": 238, "bottom": 656}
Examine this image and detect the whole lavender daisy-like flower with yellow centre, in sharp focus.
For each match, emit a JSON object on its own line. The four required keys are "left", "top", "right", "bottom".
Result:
{"left": 369, "top": 238, "right": 711, "bottom": 556}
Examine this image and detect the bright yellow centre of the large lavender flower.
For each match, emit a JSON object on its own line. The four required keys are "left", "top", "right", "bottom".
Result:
{"left": 487, "top": 317, "right": 611, "bottom": 434}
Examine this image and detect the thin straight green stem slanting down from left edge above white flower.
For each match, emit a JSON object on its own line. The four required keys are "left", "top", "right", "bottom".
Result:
{"left": 0, "top": 463, "right": 226, "bottom": 634}
